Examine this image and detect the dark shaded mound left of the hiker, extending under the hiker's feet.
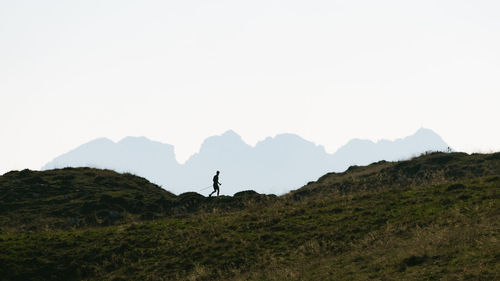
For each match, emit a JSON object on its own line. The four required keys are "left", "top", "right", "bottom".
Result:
{"left": 0, "top": 168, "right": 276, "bottom": 233}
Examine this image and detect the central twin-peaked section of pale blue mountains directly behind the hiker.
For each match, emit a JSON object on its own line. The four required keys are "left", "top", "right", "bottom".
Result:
{"left": 180, "top": 131, "right": 328, "bottom": 194}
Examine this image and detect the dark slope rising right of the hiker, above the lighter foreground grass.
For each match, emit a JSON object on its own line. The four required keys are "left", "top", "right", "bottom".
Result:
{"left": 290, "top": 152, "right": 500, "bottom": 199}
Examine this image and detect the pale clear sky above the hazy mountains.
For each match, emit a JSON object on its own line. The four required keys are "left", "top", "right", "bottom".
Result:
{"left": 0, "top": 0, "right": 500, "bottom": 173}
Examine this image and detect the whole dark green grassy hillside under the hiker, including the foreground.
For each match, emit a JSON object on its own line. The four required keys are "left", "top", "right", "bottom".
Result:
{"left": 0, "top": 153, "right": 500, "bottom": 280}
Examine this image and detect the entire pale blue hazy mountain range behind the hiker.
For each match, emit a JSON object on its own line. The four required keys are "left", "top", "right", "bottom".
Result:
{"left": 42, "top": 129, "right": 448, "bottom": 194}
